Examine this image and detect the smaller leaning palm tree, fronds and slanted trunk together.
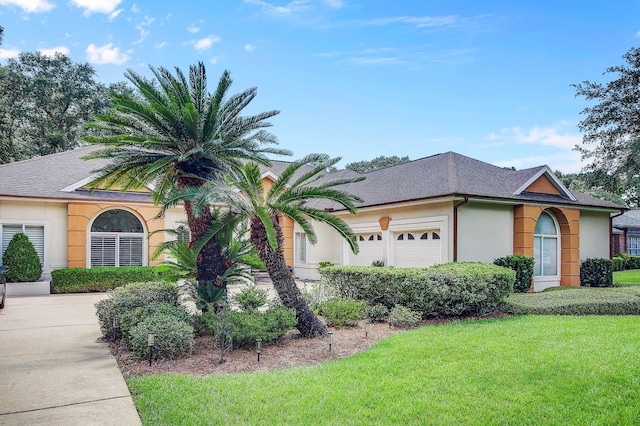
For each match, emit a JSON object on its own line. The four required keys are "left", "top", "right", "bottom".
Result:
{"left": 189, "top": 154, "right": 364, "bottom": 337}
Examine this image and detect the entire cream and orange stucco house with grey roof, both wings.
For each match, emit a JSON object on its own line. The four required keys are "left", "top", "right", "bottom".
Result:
{"left": 0, "top": 147, "right": 624, "bottom": 291}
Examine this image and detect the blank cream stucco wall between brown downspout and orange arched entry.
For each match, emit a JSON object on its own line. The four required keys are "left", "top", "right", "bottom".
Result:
{"left": 458, "top": 201, "right": 513, "bottom": 263}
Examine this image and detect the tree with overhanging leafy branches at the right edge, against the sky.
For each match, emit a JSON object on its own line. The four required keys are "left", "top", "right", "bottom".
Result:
{"left": 573, "top": 47, "right": 640, "bottom": 206}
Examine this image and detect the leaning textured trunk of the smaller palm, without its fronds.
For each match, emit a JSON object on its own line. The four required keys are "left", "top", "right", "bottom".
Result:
{"left": 251, "top": 218, "right": 327, "bottom": 337}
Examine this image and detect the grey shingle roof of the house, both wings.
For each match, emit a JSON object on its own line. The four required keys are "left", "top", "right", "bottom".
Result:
{"left": 0, "top": 146, "right": 622, "bottom": 210}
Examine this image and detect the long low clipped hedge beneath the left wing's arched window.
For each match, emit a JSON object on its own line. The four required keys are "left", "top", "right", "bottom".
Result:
{"left": 51, "top": 266, "right": 162, "bottom": 293}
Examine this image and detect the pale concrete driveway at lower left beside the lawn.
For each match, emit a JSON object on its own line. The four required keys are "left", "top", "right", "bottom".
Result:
{"left": 0, "top": 294, "right": 141, "bottom": 426}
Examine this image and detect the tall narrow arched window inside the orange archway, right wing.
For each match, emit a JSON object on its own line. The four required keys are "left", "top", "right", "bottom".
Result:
{"left": 533, "top": 211, "right": 559, "bottom": 277}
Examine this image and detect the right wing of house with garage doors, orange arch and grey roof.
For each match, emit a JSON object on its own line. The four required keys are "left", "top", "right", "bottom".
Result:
{"left": 294, "top": 152, "right": 625, "bottom": 291}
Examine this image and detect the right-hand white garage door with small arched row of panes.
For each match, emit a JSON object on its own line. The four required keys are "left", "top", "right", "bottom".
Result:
{"left": 393, "top": 229, "right": 441, "bottom": 268}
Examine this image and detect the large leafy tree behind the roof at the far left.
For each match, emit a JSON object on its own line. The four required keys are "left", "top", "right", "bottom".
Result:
{"left": 0, "top": 52, "right": 110, "bottom": 163}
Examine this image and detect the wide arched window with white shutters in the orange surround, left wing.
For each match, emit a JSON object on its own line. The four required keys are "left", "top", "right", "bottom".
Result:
{"left": 89, "top": 209, "right": 145, "bottom": 268}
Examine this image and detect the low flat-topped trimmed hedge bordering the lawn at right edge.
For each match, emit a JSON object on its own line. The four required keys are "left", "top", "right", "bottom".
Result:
{"left": 505, "top": 286, "right": 640, "bottom": 315}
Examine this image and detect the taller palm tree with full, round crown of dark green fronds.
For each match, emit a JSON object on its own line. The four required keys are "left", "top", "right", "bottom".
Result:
{"left": 86, "top": 62, "right": 290, "bottom": 286}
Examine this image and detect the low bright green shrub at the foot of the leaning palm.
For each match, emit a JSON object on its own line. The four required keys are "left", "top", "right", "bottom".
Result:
{"left": 201, "top": 308, "right": 298, "bottom": 347}
